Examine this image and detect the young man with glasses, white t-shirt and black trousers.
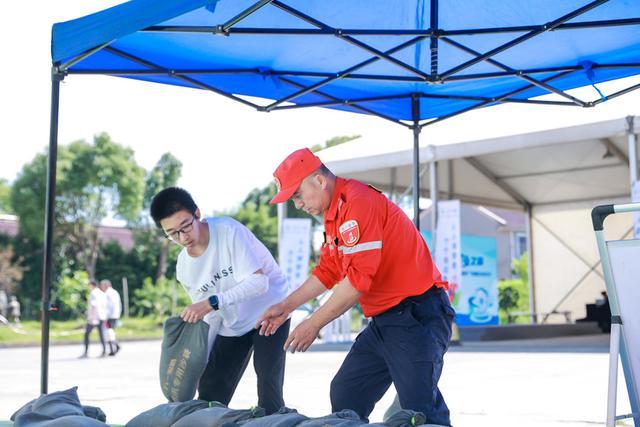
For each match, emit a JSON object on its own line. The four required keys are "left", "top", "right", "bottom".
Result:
{"left": 150, "top": 187, "right": 290, "bottom": 414}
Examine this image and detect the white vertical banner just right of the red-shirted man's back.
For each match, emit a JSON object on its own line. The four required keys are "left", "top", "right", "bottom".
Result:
{"left": 435, "top": 200, "right": 462, "bottom": 300}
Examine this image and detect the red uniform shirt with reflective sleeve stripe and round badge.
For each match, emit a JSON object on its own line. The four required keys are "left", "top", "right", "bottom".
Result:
{"left": 313, "top": 178, "right": 447, "bottom": 317}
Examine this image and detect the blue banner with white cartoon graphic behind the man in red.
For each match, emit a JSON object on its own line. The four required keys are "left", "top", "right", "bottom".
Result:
{"left": 422, "top": 232, "right": 498, "bottom": 326}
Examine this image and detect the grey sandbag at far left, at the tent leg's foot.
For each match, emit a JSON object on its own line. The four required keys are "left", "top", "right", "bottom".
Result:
{"left": 11, "top": 387, "right": 106, "bottom": 427}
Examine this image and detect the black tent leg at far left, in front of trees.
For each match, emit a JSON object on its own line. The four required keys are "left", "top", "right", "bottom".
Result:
{"left": 40, "top": 67, "right": 63, "bottom": 394}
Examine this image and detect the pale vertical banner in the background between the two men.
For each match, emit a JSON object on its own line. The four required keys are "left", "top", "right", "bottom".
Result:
{"left": 278, "top": 218, "right": 311, "bottom": 289}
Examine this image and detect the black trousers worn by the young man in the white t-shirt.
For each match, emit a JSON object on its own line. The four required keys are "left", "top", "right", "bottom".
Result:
{"left": 198, "top": 320, "right": 291, "bottom": 414}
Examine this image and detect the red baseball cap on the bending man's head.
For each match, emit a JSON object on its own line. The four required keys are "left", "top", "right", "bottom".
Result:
{"left": 270, "top": 148, "right": 322, "bottom": 204}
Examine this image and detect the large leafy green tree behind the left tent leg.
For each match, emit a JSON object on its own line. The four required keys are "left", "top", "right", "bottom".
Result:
{"left": 11, "top": 133, "right": 144, "bottom": 296}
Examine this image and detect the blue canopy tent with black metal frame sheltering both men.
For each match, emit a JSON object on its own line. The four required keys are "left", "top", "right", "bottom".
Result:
{"left": 48, "top": 0, "right": 640, "bottom": 416}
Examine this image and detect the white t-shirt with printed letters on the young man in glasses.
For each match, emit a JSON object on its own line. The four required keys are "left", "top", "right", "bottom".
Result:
{"left": 176, "top": 217, "right": 290, "bottom": 337}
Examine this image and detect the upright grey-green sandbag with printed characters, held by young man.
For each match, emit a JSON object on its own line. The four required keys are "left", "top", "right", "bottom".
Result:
{"left": 160, "top": 316, "right": 209, "bottom": 402}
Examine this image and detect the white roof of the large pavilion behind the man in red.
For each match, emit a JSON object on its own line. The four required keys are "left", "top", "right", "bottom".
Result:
{"left": 319, "top": 117, "right": 640, "bottom": 208}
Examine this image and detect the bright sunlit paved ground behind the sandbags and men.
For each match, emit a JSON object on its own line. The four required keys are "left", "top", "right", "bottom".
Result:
{"left": 0, "top": 335, "right": 632, "bottom": 427}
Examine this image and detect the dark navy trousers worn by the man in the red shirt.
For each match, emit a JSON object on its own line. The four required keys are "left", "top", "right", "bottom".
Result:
{"left": 330, "top": 287, "right": 455, "bottom": 426}
